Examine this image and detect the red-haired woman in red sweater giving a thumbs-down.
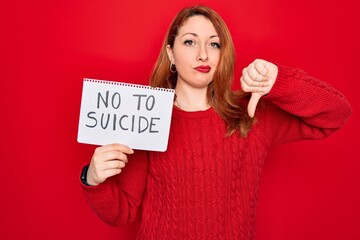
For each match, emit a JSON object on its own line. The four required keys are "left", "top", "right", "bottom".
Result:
{"left": 82, "top": 6, "right": 351, "bottom": 239}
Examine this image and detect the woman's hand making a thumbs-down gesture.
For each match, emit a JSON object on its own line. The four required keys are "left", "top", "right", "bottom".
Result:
{"left": 240, "top": 59, "right": 278, "bottom": 117}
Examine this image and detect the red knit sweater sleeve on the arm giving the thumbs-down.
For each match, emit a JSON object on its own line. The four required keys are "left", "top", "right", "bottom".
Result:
{"left": 258, "top": 66, "right": 352, "bottom": 145}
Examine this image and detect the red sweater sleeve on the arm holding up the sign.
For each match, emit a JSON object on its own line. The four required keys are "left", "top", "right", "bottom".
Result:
{"left": 81, "top": 151, "right": 148, "bottom": 226}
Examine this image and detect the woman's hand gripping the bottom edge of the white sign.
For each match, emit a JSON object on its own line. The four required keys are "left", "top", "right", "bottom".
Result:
{"left": 86, "top": 143, "right": 134, "bottom": 186}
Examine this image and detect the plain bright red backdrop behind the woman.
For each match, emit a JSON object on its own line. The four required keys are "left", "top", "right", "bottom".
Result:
{"left": 0, "top": 0, "right": 360, "bottom": 240}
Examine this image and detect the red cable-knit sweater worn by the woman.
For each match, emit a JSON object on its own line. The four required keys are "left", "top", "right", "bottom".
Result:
{"left": 83, "top": 66, "right": 351, "bottom": 240}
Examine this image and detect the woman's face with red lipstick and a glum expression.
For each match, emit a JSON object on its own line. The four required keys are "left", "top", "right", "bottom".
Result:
{"left": 167, "top": 16, "right": 220, "bottom": 88}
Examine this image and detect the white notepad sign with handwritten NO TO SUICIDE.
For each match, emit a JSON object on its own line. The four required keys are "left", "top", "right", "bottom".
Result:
{"left": 78, "top": 78, "right": 174, "bottom": 151}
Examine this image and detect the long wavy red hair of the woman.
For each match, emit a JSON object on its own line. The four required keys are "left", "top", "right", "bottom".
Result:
{"left": 150, "top": 6, "right": 254, "bottom": 136}
